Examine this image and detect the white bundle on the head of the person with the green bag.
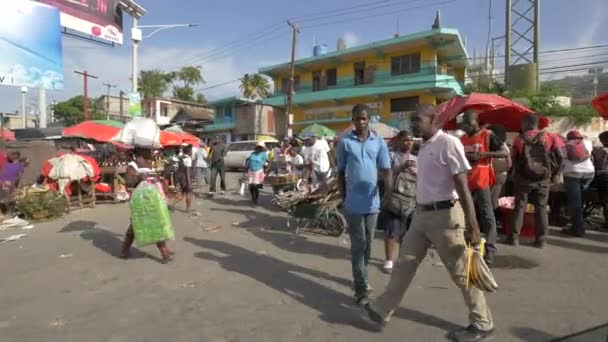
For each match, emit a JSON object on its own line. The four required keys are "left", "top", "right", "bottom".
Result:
{"left": 112, "top": 118, "right": 161, "bottom": 148}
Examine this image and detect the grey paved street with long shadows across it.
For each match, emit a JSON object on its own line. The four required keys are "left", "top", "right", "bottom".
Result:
{"left": 0, "top": 176, "right": 608, "bottom": 342}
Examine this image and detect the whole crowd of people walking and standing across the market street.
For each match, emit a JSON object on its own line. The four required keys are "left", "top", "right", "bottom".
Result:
{"left": 98, "top": 101, "right": 608, "bottom": 341}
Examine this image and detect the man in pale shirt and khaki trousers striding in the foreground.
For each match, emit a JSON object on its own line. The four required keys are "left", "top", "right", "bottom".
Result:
{"left": 365, "top": 106, "right": 494, "bottom": 341}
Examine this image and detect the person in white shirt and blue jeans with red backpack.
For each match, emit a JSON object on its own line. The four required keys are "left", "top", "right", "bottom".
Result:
{"left": 562, "top": 130, "right": 594, "bottom": 237}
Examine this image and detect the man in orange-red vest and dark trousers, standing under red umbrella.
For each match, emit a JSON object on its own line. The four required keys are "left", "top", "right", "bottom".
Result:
{"left": 458, "top": 112, "right": 509, "bottom": 265}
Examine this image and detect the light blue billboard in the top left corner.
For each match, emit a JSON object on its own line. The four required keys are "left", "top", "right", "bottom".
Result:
{"left": 0, "top": 0, "right": 63, "bottom": 89}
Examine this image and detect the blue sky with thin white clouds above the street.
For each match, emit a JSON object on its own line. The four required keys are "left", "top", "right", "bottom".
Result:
{"left": 0, "top": 0, "right": 608, "bottom": 112}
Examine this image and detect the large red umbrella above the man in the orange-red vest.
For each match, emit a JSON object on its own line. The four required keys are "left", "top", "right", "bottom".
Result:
{"left": 437, "top": 93, "right": 551, "bottom": 132}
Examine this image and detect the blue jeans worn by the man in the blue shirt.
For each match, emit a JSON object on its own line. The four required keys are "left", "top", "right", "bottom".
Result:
{"left": 346, "top": 214, "right": 378, "bottom": 297}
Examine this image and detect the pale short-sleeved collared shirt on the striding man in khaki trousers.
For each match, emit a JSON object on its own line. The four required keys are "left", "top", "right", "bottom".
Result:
{"left": 416, "top": 130, "right": 471, "bottom": 204}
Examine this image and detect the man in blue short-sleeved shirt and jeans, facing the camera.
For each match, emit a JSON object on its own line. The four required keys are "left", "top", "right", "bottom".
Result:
{"left": 337, "top": 104, "right": 392, "bottom": 305}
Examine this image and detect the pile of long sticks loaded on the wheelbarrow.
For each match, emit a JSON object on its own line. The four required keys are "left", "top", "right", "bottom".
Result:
{"left": 272, "top": 177, "right": 341, "bottom": 210}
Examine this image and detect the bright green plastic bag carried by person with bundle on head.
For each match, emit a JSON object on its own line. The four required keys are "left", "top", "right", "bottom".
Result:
{"left": 129, "top": 181, "right": 175, "bottom": 247}
